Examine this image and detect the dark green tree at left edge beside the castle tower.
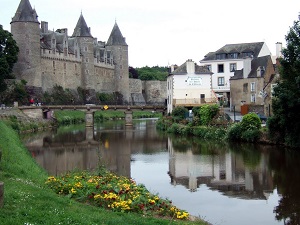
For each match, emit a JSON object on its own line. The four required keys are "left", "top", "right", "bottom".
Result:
{"left": 0, "top": 25, "right": 19, "bottom": 92}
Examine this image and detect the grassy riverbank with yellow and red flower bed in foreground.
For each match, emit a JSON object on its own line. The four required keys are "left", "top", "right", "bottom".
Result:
{"left": 0, "top": 120, "right": 206, "bottom": 225}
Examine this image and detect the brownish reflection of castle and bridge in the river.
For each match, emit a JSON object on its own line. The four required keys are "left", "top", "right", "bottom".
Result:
{"left": 26, "top": 121, "right": 166, "bottom": 177}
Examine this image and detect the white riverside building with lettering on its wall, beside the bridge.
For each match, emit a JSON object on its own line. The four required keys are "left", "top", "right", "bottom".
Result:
{"left": 167, "top": 59, "right": 217, "bottom": 113}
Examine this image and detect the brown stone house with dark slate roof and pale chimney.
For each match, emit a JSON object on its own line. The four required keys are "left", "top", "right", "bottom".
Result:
{"left": 230, "top": 55, "right": 276, "bottom": 116}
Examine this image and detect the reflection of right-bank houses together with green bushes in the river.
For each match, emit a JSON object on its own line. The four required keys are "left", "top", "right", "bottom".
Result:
{"left": 168, "top": 138, "right": 274, "bottom": 199}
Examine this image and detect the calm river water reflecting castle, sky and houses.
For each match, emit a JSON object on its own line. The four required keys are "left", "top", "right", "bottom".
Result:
{"left": 22, "top": 119, "right": 300, "bottom": 225}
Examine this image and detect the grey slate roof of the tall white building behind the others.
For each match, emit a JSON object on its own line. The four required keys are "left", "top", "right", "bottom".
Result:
{"left": 201, "top": 42, "right": 264, "bottom": 61}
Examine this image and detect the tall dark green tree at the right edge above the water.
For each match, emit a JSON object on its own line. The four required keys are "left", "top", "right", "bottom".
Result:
{"left": 267, "top": 16, "right": 300, "bottom": 147}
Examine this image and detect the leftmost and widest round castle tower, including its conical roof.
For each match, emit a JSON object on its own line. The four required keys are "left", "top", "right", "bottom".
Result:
{"left": 10, "top": 0, "right": 42, "bottom": 89}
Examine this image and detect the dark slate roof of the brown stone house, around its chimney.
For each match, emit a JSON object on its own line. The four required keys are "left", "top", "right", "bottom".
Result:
{"left": 230, "top": 55, "right": 272, "bottom": 80}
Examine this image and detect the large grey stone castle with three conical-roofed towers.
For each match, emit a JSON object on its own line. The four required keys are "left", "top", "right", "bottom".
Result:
{"left": 11, "top": 0, "right": 131, "bottom": 103}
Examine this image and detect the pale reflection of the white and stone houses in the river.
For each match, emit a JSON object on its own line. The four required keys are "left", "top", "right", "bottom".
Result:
{"left": 168, "top": 138, "right": 273, "bottom": 199}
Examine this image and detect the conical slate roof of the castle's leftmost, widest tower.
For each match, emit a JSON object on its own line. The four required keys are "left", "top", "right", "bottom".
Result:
{"left": 11, "top": 0, "right": 39, "bottom": 23}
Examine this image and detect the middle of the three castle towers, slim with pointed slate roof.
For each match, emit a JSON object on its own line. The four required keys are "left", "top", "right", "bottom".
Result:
{"left": 72, "top": 14, "right": 95, "bottom": 92}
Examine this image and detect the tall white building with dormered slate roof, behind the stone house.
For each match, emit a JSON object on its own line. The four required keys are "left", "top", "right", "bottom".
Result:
{"left": 200, "top": 42, "right": 271, "bottom": 107}
